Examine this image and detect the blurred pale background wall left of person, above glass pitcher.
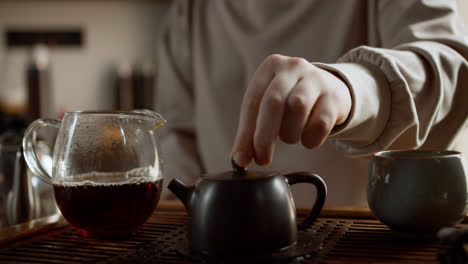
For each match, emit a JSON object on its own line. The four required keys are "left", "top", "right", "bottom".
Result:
{"left": 0, "top": 0, "right": 171, "bottom": 117}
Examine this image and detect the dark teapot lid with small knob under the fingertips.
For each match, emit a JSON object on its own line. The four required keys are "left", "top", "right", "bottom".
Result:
{"left": 203, "top": 160, "right": 279, "bottom": 181}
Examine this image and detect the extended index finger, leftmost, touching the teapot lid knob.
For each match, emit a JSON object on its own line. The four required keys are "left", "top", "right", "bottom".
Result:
{"left": 231, "top": 56, "right": 278, "bottom": 167}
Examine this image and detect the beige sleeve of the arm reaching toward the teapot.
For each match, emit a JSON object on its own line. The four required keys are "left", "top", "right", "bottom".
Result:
{"left": 317, "top": 0, "right": 468, "bottom": 156}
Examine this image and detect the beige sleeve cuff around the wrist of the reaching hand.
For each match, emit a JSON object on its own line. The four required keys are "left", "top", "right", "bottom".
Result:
{"left": 314, "top": 63, "right": 391, "bottom": 147}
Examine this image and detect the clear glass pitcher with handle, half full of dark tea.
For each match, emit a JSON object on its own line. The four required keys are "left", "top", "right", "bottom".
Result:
{"left": 23, "top": 110, "right": 166, "bottom": 237}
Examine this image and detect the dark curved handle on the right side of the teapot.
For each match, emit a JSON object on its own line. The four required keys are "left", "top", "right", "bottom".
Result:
{"left": 285, "top": 172, "right": 327, "bottom": 230}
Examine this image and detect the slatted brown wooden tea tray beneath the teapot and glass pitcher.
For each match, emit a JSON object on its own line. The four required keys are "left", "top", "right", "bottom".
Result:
{"left": 0, "top": 201, "right": 465, "bottom": 263}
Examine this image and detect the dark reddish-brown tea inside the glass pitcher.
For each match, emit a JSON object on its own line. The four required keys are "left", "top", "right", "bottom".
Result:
{"left": 53, "top": 168, "right": 162, "bottom": 238}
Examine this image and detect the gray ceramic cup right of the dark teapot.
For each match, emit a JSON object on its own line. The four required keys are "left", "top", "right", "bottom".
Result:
{"left": 366, "top": 150, "right": 467, "bottom": 236}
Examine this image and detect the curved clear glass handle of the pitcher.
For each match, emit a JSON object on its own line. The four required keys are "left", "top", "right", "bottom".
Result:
{"left": 23, "top": 119, "right": 61, "bottom": 184}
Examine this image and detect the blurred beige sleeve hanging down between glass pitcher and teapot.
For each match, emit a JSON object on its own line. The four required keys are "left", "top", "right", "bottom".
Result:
{"left": 156, "top": 1, "right": 201, "bottom": 199}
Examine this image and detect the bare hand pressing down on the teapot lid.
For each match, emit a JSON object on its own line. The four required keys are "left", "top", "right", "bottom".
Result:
{"left": 231, "top": 55, "right": 351, "bottom": 167}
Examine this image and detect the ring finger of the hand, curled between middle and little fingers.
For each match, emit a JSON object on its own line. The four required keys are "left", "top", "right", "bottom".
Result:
{"left": 280, "top": 79, "right": 319, "bottom": 144}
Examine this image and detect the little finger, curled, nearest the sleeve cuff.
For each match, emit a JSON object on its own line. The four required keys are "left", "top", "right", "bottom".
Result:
{"left": 301, "top": 96, "right": 338, "bottom": 149}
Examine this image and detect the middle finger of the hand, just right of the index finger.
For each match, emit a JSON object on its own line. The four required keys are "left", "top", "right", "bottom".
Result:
{"left": 253, "top": 74, "right": 297, "bottom": 165}
